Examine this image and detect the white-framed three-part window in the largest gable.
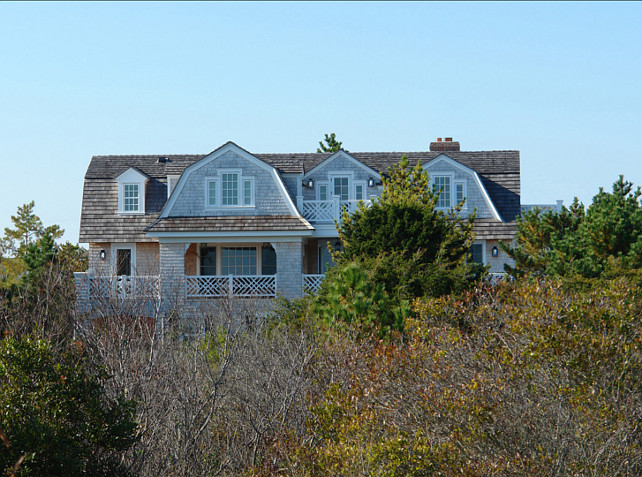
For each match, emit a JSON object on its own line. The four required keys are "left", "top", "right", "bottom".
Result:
{"left": 205, "top": 171, "right": 254, "bottom": 207}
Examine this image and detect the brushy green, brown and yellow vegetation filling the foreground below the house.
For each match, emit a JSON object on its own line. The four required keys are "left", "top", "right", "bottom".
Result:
{"left": 0, "top": 169, "right": 642, "bottom": 476}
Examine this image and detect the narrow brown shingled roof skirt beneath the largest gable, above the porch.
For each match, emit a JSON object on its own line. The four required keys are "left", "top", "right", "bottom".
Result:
{"left": 146, "top": 215, "right": 314, "bottom": 233}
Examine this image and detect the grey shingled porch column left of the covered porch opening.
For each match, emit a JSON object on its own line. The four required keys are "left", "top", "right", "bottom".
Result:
{"left": 160, "top": 243, "right": 187, "bottom": 310}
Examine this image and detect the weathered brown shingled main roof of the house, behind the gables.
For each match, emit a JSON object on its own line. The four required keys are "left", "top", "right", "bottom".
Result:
{"left": 79, "top": 145, "right": 520, "bottom": 243}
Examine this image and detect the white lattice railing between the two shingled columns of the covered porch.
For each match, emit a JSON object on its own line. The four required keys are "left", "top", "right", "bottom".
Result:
{"left": 185, "top": 275, "right": 276, "bottom": 298}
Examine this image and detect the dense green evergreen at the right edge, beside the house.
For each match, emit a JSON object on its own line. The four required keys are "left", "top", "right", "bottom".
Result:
{"left": 503, "top": 176, "right": 642, "bottom": 278}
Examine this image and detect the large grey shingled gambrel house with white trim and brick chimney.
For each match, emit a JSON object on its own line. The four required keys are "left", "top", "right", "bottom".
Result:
{"left": 76, "top": 138, "right": 520, "bottom": 309}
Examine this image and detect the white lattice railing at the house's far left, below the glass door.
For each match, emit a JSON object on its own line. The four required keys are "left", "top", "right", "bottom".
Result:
{"left": 87, "top": 275, "right": 160, "bottom": 298}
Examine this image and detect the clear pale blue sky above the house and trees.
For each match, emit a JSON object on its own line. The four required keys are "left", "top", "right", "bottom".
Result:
{"left": 0, "top": 2, "right": 642, "bottom": 243}
